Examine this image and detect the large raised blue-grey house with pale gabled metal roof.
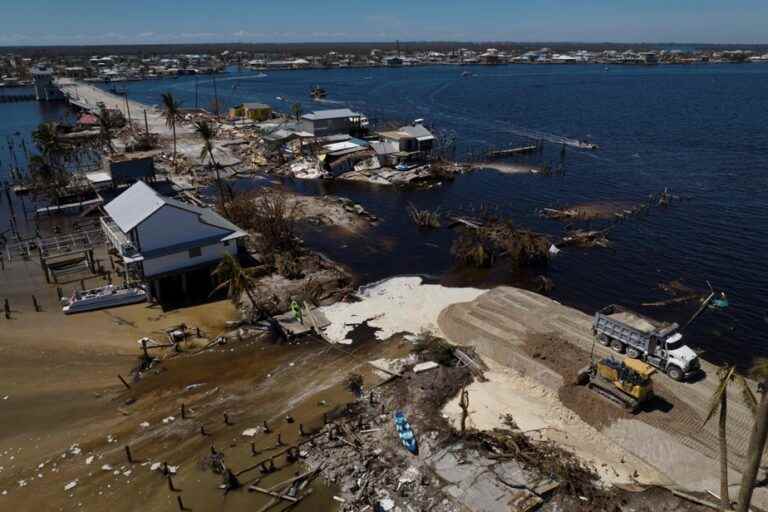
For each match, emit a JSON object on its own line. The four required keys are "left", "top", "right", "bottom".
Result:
{"left": 101, "top": 181, "right": 247, "bottom": 302}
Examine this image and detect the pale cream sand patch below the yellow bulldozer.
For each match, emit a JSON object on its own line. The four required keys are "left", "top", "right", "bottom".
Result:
{"left": 443, "top": 358, "right": 669, "bottom": 484}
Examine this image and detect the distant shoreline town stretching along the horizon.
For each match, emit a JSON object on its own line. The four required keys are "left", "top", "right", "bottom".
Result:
{"left": 0, "top": 44, "right": 768, "bottom": 87}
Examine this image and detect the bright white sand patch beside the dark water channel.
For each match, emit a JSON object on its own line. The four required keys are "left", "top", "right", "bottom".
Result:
{"left": 320, "top": 277, "right": 485, "bottom": 344}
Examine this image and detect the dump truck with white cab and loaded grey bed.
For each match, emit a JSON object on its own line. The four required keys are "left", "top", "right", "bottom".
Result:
{"left": 592, "top": 305, "right": 701, "bottom": 381}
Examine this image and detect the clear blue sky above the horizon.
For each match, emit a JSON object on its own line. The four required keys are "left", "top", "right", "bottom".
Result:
{"left": 0, "top": 0, "right": 768, "bottom": 46}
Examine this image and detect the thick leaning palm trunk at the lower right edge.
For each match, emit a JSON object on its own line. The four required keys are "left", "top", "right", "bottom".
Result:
{"left": 736, "top": 359, "right": 768, "bottom": 512}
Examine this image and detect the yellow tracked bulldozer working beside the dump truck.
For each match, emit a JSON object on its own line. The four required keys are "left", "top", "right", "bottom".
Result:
{"left": 577, "top": 357, "right": 656, "bottom": 412}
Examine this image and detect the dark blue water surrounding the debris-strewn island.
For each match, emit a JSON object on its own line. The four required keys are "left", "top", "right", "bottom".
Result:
{"left": 0, "top": 64, "right": 768, "bottom": 368}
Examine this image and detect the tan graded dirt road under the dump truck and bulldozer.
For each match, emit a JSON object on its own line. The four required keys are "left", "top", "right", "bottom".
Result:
{"left": 438, "top": 287, "right": 768, "bottom": 502}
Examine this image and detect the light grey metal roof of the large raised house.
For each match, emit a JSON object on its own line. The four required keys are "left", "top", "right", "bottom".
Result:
{"left": 104, "top": 181, "right": 246, "bottom": 240}
